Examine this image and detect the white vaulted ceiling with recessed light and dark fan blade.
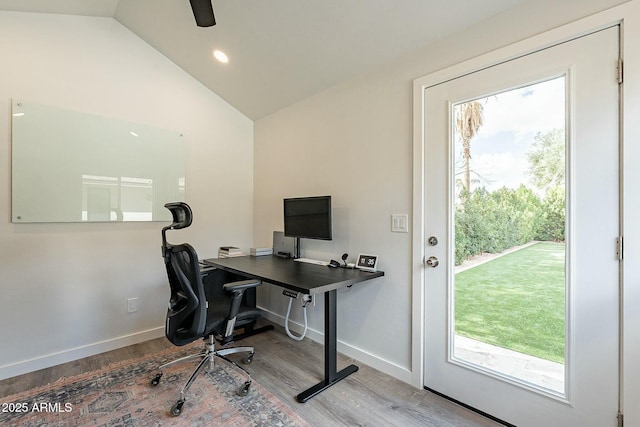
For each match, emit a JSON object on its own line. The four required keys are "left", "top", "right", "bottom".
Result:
{"left": 0, "top": 0, "right": 524, "bottom": 120}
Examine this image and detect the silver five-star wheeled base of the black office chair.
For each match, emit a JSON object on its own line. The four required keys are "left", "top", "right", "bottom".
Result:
{"left": 151, "top": 335, "right": 254, "bottom": 417}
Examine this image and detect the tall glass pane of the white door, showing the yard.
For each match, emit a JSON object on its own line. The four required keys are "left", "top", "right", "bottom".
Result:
{"left": 451, "top": 76, "right": 568, "bottom": 395}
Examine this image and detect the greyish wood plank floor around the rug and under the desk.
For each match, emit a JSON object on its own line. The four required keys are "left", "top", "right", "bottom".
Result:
{"left": 0, "top": 326, "right": 501, "bottom": 427}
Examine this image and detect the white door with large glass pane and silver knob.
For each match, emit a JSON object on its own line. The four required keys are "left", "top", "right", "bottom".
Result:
{"left": 424, "top": 27, "right": 619, "bottom": 427}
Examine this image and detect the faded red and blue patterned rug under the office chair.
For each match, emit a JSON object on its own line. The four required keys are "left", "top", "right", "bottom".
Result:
{"left": 0, "top": 343, "right": 308, "bottom": 427}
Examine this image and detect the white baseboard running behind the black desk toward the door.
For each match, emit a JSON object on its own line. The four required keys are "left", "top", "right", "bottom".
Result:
{"left": 258, "top": 307, "right": 413, "bottom": 386}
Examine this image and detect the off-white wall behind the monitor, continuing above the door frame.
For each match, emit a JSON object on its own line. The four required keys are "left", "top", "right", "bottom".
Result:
{"left": 254, "top": 0, "right": 624, "bottom": 398}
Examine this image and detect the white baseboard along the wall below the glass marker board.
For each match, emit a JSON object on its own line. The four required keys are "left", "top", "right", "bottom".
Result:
{"left": 0, "top": 326, "right": 164, "bottom": 380}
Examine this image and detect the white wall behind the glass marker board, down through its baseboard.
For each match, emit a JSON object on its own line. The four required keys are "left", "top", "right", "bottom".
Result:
{"left": 0, "top": 12, "right": 253, "bottom": 379}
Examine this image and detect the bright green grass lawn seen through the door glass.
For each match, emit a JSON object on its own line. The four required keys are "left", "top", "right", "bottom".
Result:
{"left": 455, "top": 242, "right": 565, "bottom": 363}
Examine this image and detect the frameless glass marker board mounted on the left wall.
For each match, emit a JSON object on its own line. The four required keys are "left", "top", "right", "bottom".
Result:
{"left": 11, "top": 100, "right": 185, "bottom": 223}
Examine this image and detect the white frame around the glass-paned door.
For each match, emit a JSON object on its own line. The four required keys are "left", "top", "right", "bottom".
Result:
{"left": 411, "top": 0, "right": 640, "bottom": 424}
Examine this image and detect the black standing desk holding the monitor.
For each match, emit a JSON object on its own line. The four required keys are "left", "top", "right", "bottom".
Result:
{"left": 204, "top": 256, "right": 384, "bottom": 403}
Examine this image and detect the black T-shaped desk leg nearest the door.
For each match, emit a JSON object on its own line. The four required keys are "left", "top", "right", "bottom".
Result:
{"left": 296, "top": 290, "right": 358, "bottom": 403}
